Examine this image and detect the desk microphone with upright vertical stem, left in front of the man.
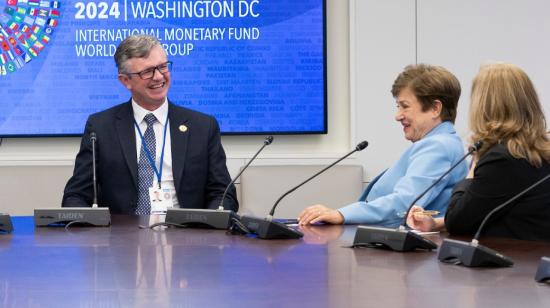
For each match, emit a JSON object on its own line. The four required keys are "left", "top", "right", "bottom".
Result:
{"left": 34, "top": 132, "right": 111, "bottom": 228}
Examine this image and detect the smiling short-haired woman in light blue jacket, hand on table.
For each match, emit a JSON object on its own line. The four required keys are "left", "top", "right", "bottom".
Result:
{"left": 298, "top": 64, "right": 467, "bottom": 226}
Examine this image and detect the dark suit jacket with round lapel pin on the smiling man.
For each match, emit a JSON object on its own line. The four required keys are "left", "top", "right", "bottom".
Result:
{"left": 62, "top": 102, "right": 239, "bottom": 214}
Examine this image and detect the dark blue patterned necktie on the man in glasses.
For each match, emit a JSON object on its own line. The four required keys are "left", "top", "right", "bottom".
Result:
{"left": 136, "top": 113, "right": 157, "bottom": 215}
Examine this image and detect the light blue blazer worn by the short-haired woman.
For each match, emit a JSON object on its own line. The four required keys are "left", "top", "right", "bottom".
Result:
{"left": 338, "top": 122, "right": 468, "bottom": 227}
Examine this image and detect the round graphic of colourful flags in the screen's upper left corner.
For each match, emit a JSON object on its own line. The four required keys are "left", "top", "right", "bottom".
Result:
{"left": 0, "top": 0, "right": 61, "bottom": 76}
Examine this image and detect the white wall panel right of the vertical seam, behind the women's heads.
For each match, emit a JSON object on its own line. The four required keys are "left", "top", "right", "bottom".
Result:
{"left": 418, "top": 0, "right": 550, "bottom": 140}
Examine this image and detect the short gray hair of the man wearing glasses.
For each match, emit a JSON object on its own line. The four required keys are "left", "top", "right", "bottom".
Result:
{"left": 115, "top": 34, "right": 161, "bottom": 74}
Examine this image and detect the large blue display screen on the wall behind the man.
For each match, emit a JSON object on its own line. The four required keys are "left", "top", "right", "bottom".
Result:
{"left": 0, "top": 0, "right": 327, "bottom": 137}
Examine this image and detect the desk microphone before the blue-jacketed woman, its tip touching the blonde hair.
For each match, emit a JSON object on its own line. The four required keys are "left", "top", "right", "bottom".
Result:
{"left": 351, "top": 140, "right": 483, "bottom": 251}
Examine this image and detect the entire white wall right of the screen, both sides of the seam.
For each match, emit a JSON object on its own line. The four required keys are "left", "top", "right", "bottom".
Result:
{"left": 350, "top": 0, "right": 550, "bottom": 180}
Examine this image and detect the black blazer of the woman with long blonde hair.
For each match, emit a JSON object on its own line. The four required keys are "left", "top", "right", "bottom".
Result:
{"left": 445, "top": 144, "right": 550, "bottom": 241}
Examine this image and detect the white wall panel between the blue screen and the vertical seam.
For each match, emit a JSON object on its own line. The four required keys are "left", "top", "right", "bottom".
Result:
{"left": 350, "top": 0, "right": 415, "bottom": 179}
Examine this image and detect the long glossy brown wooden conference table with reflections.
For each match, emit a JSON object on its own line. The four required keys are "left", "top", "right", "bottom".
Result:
{"left": 0, "top": 215, "right": 550, "bottom": 308}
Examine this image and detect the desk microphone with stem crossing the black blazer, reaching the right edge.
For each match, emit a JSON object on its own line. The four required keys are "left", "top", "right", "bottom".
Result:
{"left": 437, "top": 174, "right": 550, "bottom": 267}
